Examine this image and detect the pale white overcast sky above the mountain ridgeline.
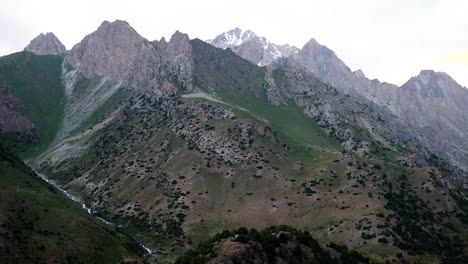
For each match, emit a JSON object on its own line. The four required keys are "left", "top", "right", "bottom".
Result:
{"left": 0, "top": 0, "right": 468, "bottom": 86}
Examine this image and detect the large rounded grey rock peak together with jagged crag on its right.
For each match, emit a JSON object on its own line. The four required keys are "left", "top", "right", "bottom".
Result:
{"left": 65, "top": 20, "right": 193, "bottom": 97}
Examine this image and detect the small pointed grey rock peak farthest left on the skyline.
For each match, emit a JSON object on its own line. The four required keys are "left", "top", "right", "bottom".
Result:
{"left": 24, "top": 32, "right": 67, "bottom": 55}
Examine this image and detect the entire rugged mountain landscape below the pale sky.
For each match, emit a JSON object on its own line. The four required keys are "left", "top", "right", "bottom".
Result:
{"left": 0, "top": 20, "right": 468, "bottom": 263}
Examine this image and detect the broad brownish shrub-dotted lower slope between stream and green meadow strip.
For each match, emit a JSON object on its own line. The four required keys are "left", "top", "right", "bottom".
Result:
{"left": 36, "top": 90, "right": 465, "bottom": 261}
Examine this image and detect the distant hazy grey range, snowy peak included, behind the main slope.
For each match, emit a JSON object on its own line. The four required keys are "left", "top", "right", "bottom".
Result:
{"left": 208, "top": 29, "right": 468, "bottom": 194}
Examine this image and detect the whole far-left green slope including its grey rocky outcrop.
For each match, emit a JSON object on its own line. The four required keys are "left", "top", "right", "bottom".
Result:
{"left": 0, "top": 51, "right": 65, "bottom": 157}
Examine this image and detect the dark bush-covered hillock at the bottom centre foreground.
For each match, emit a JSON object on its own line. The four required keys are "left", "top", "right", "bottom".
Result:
{"left": 176, "top": 226, "right": 371, "bottom": 264}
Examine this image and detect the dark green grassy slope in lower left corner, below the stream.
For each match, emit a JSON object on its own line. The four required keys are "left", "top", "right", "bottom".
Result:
{"left": 0, "top": 146, "right": 142, "bottom": 263}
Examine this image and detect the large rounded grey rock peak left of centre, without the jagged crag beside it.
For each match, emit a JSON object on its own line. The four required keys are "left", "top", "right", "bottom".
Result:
{"left": 65, "top": 20, "right": 162, "bottom": 95}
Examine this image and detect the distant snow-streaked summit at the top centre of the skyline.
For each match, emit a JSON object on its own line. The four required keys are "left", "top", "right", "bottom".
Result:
{"left": 206, "top": 28, "right": 299, "bottom": 66}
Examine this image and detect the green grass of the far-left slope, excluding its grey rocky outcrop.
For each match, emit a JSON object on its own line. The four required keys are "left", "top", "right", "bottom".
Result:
{"left": 0, "top": 52, "right": 64, "bottom": 157}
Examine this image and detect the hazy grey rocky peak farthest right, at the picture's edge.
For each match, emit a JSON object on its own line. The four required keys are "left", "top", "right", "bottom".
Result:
{"left": 389, "top": 70, "right": 468, "bottom": 172}
